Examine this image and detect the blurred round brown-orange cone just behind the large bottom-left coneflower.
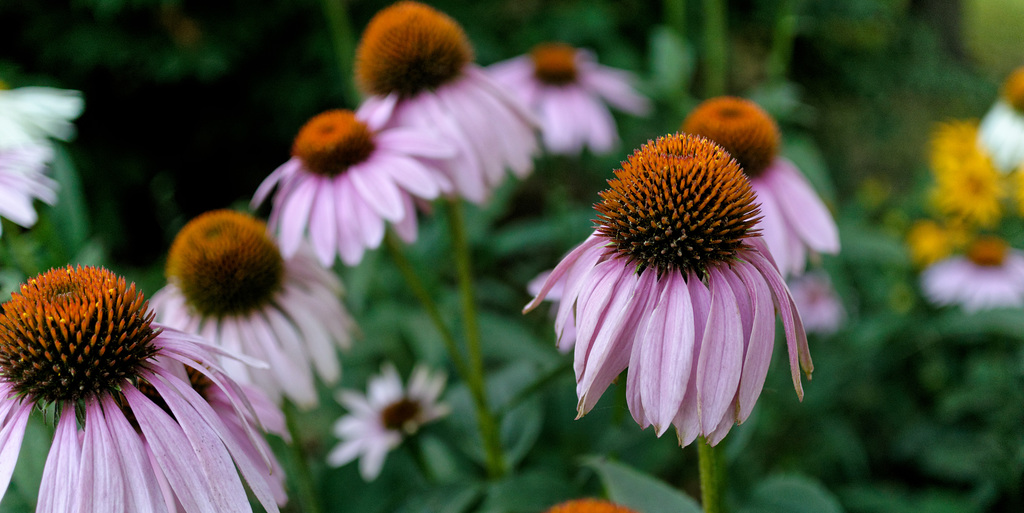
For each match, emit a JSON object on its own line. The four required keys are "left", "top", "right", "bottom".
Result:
{"left": 167, "top": 210, "right": 285, "bottom": 317}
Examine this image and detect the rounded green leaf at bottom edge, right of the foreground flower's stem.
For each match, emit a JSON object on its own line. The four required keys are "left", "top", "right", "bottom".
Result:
{"left": 739, "top": 475, "right": 843, "bottom": 513}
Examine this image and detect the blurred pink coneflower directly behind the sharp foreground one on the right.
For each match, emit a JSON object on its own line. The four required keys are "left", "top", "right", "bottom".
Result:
{"left": 682, "top": 96, "right": 840, "bottom": 275}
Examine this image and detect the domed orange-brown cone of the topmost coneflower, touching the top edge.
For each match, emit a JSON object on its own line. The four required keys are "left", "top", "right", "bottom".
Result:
{"left": 355, "top": 1, "right": 473, "bottom": 96}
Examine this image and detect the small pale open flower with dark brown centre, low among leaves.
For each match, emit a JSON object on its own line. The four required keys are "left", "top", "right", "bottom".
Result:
{"left": 327, "top": 364, "right": 450, "bottom": 481}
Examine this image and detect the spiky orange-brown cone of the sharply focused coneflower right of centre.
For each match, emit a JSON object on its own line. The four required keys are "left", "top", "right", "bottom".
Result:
{"left": 595, "top": 133, "right": 759, "bottom": 275}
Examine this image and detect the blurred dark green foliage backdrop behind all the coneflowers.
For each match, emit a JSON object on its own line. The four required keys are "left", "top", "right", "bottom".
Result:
{"left": 0, "top": 0, "right": 1024, "bottom": 513}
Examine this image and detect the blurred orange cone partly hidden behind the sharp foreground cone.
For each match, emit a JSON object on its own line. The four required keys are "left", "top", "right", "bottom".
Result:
{"left": 682, "top": 96, "right": 779, "bottom": 177}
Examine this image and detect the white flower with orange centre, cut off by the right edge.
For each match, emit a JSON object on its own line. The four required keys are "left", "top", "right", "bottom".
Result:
{"left": 977, "top": 67, "right": 1024, "bottom": 173}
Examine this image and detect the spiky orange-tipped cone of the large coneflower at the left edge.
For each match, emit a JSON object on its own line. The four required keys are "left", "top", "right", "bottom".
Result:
{"left": 0, "top": 266, "right": 159, "bottom": 403}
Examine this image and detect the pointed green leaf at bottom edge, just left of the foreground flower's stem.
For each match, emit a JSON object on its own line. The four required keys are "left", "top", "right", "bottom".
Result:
{"left": 584, "top": 457, "right": 701, "bottom": 513}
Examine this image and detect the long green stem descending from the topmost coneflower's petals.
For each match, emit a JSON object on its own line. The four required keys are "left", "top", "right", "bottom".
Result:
{"left": 447, "top": 199, "right": 505, "bottom": 478}
